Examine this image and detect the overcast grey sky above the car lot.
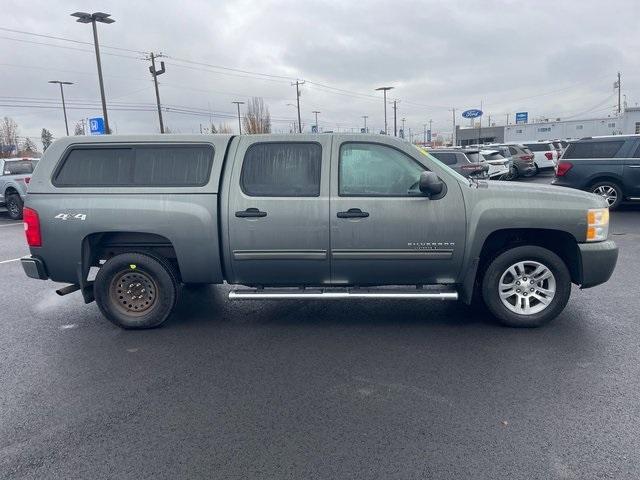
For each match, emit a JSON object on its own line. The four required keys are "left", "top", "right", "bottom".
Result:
{"left": 0, "top": 0, "right": 640, "bottom": 145}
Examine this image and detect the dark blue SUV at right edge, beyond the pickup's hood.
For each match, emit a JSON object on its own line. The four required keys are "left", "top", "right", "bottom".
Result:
{"left": 552, "top": 135, "right": 640, "bottom": 210}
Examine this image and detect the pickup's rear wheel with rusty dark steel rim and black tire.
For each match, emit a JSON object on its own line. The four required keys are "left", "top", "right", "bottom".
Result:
{"left": 93, "top": 253, "right": 178, "bottom": 329}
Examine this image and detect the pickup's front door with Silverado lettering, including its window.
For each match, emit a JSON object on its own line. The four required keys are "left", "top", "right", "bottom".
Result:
{"left": 331, "top": 136, "right": 465, "bottom": 285}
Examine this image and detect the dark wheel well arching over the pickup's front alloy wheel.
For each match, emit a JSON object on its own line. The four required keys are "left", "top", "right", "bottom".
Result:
{"left": 476, "top": 228, "right": 581, "bottom": 283}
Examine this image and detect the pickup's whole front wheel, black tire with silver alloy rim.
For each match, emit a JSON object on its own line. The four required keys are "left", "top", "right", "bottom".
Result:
{"left": 482, "top": 245, "right": 571, "bottom": 327}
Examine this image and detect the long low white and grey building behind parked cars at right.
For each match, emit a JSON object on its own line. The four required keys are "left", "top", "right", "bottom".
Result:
{"left": 456, "top": 107, "right": 640, "bottom": 146}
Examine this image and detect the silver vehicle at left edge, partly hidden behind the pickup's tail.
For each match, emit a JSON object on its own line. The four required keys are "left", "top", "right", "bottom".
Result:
{"left": 0, "top": 158, "right": 38, "bottom": 220}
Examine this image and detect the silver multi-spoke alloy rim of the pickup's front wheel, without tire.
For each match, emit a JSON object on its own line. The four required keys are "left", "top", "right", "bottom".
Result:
{"left": 498, "top": 260, "right": 556, "bottom": 315}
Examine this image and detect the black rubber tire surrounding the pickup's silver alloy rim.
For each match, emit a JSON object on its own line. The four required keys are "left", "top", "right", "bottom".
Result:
{"left": 482, "top": 245, "right": 571, "bottom": 327}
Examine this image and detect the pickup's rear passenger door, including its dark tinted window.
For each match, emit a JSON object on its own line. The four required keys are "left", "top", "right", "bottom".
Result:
{"left": 226, "top": 135, "right": 331, "bottom": 286}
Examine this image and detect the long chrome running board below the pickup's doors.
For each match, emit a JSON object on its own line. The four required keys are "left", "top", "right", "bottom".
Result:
{"left": 229, "top": 288, "right": 458, "bottom": 300}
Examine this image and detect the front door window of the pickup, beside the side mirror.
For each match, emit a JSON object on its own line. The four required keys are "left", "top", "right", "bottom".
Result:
{"left": 338, "top": 142, "right": 426, "bottom": 197}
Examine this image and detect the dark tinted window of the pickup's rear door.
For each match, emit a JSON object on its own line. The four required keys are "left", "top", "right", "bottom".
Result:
{"left": 240, "top": 142, "right": 322, "bottom": 197}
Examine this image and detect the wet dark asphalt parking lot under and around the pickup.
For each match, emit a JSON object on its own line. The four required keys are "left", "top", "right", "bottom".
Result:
{"left": 0, "top": 172, "right": 640, "bottom": 480}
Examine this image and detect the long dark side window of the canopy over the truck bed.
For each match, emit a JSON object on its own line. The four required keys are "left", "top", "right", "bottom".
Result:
{"left": 53, "top": 144, "right": 214, "bottom": 187}
